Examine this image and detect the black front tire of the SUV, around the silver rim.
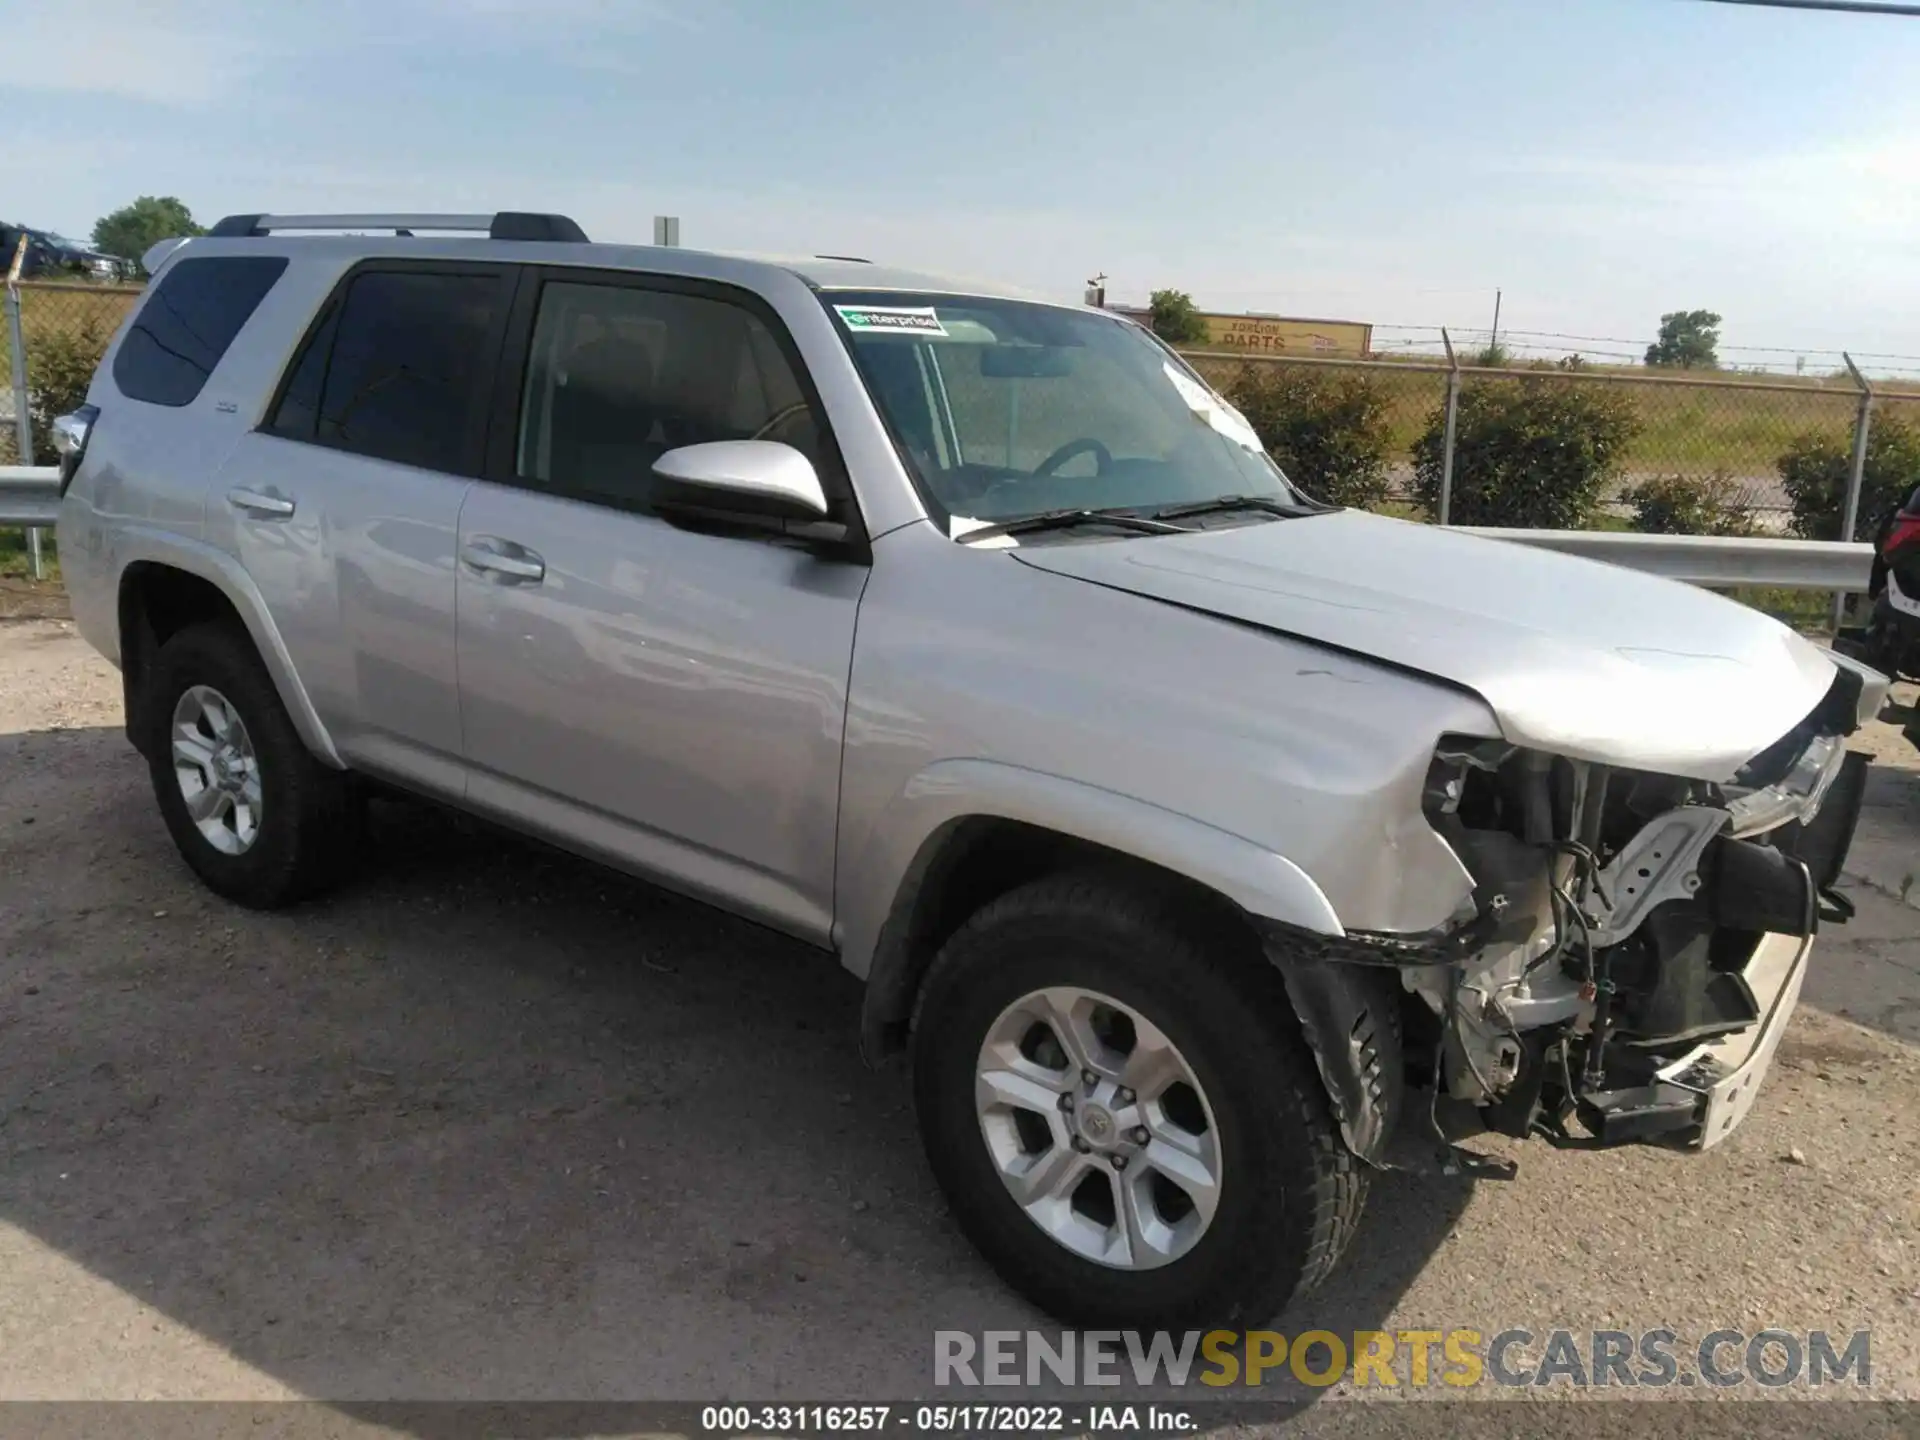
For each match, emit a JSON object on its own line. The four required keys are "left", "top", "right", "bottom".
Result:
{"left": 912, "top": 874, "right": 1367, "bottom": 1329}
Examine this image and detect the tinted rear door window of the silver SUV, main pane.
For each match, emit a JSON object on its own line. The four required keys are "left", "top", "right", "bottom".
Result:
{"left": 314, "top": 271, "right": 499, "bottom": 470}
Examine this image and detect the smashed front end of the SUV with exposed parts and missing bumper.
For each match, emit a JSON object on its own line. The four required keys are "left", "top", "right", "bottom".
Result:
{"left": 1267, "top": 666, "right": 1885, "bottom": 1173}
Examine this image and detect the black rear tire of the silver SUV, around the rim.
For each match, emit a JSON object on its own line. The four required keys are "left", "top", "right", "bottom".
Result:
{"left": 140, "top": 622, "right": 363, "bottom": 910}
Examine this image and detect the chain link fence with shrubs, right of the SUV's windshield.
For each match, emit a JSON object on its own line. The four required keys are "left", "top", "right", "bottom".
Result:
{"left": 1188, "top": 351, "right": 1920, "bottom": 540}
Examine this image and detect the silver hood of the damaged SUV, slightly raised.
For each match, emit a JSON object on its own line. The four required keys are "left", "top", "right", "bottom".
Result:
{"left": 1014, "top": 511, "right": 1834, "bottom": 780}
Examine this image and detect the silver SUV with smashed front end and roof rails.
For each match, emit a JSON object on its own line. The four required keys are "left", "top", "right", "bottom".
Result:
{"left": 58, "top": 213, "right": 1885, "bottom": 1325}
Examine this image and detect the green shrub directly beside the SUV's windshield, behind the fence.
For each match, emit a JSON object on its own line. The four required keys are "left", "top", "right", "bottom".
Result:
{"left": 1227, "top": 365, "right": 1392, "bottom": 509}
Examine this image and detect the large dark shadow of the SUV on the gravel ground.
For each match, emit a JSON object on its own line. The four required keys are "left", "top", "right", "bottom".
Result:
{"left": 0, "top": 730, "right": 1471, "bottom": 1434}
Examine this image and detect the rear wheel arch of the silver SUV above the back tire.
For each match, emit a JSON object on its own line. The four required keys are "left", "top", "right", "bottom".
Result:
{"left": 115, "top": 532, "right": 346, "bottom": 770}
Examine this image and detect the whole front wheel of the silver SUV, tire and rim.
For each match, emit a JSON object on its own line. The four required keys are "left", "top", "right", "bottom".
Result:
{"left": 914, "top": 876, "right": 1365, "bottom": 1327}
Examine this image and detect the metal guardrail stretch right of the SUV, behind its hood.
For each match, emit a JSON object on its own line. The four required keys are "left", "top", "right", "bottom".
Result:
{"left": 1455, "top": 526, "right": 1874, "bottom": 593}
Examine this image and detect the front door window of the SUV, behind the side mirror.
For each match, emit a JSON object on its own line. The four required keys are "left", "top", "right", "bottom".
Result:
{"left": 516, "top": 282, "right": 828, "bottom": 509}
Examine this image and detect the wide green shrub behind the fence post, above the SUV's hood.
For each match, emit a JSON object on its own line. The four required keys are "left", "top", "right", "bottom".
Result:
{"left": 1413, "top": 376, "right": 1640, "bottom": 530}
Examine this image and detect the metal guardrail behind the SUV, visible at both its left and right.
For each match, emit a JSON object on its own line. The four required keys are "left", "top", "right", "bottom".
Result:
{"left": 0, "top": 465, "right": 1874, "bottom": 591}
